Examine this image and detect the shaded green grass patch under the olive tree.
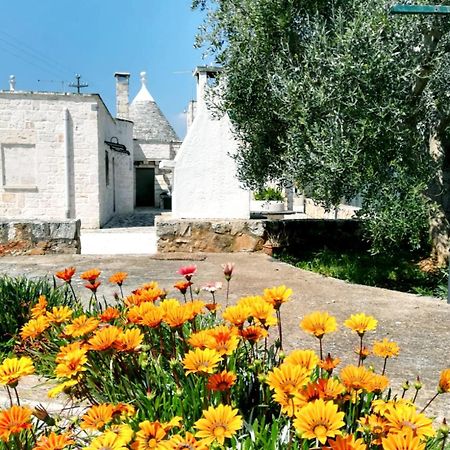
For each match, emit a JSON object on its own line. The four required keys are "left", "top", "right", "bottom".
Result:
{"left": 279, "top": 249, "right": 448, "bottom": 298}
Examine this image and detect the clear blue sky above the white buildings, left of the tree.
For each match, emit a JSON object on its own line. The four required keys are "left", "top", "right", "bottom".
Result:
{"left": 0, "top": 0, "right": 205, "bottom": 138}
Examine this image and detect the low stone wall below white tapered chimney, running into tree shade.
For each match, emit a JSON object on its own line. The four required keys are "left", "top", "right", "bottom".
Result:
{"left": 156, "top": 215, "right": 364, "bottom": 254}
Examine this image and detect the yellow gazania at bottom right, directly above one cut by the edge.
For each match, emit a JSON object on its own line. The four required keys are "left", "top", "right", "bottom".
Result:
{"left": 384, "top": 407, "right": 435, "bottom": 437}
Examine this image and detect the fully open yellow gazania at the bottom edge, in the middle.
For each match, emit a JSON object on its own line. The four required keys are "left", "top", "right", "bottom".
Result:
{"left": 195, "top": 405, "right": 242, "bottom": 445}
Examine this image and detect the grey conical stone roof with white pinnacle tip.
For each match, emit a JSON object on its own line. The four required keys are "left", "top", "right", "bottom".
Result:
{"left": 130, "top": 72, "right": 179, "bottom": 142}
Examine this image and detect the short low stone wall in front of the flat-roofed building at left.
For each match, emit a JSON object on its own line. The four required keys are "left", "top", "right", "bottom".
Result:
{"left": 0, "top": 219, "right": 81, "bottom": 256}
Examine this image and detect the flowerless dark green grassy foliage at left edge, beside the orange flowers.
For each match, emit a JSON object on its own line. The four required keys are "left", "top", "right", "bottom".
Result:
{"left": 0, "top": 275, "right": 71, "bottom": 350}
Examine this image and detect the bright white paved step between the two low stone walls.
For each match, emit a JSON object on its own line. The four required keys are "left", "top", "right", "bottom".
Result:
{"left": 81, "top": 227, "right": 157, "bottom": 255}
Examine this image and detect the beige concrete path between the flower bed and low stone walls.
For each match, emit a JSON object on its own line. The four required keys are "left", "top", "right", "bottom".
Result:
{"left": 0, "top": 253, "right": 450, "bottom": 417}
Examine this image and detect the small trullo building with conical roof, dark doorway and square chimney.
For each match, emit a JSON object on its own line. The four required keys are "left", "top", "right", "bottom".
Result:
{"left": 116, "top": 72, "right": 181, "bottom": 208}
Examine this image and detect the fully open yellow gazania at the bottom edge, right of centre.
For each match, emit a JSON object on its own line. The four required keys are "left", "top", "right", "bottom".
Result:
{"left": 294, "top": 399, "right": 345, "bottom": 445}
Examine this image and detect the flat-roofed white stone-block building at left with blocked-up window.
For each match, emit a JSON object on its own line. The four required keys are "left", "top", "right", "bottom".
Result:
{"left": 0, "top": 91, "right": 134, "bottom": 228}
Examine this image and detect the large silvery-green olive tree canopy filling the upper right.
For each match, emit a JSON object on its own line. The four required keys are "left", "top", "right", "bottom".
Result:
{"left": 193, "top": 0, "right": 450, "bottom": 260}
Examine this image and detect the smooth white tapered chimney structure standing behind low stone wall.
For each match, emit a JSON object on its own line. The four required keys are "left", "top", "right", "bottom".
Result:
{"left": 172, "top": 67, "right": 250, "bottom": 219}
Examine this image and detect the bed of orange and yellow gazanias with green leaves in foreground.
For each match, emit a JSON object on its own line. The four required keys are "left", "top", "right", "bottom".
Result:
{"left": 0, "top": 263, "right": 450, "bottom": 450}
